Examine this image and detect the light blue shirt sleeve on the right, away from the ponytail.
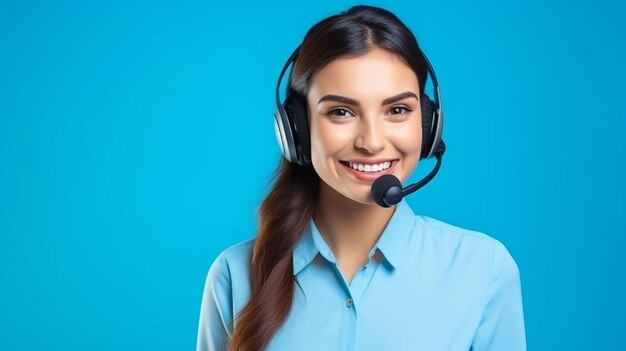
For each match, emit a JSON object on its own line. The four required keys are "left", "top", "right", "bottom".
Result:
{"left": 471, "top": 241, "right": 526, "bottom": 351}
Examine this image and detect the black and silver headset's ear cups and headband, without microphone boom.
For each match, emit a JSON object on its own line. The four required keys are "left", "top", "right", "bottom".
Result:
{"left": 274, "top": 47, "right": 445, "bottom": 166}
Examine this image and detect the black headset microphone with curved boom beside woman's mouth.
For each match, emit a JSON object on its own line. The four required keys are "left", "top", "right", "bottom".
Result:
{"left": 372, "top": 152, "right": 443, "bottom": 207}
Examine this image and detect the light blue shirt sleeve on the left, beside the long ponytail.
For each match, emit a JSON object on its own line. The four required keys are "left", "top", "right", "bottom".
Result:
{"left": 196, "top": 255, "right": 232, "bottom": 351}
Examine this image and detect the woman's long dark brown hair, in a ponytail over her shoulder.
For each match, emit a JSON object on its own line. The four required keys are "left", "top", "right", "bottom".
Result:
{"left": 229, "top": 6, "right": 426, "bottom": 351}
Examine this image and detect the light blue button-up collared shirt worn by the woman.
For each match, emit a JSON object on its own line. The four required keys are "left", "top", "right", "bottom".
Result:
{"left": 197, "top": 200, "right": 526, "bottom": 351}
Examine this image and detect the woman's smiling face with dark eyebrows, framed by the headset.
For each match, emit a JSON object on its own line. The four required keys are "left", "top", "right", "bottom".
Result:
{"left": 307, "top": 48, "right": 422, "bottom": 204}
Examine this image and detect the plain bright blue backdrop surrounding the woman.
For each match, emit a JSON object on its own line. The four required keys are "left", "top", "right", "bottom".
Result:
{"left": 0, "top": 0, "right": 626, "bottom": 350}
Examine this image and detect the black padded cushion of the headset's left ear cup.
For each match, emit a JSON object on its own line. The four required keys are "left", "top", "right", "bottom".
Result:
{"left": 284, "top": 90, "right": 311, "bottom": 166}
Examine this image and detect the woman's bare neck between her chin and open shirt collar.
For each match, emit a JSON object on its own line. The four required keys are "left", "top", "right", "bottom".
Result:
{"left": 314, "top": 182, "right": 395, "bottom": 262}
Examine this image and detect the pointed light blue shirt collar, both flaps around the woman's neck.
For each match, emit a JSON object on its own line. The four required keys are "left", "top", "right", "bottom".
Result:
{"left": 293, "top": 200, "right": 415, "bottom": 275}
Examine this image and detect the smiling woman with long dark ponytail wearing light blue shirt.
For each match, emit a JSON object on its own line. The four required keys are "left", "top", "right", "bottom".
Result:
{"left": 197, "top": 6, "right": 526, "bottom": 351}
